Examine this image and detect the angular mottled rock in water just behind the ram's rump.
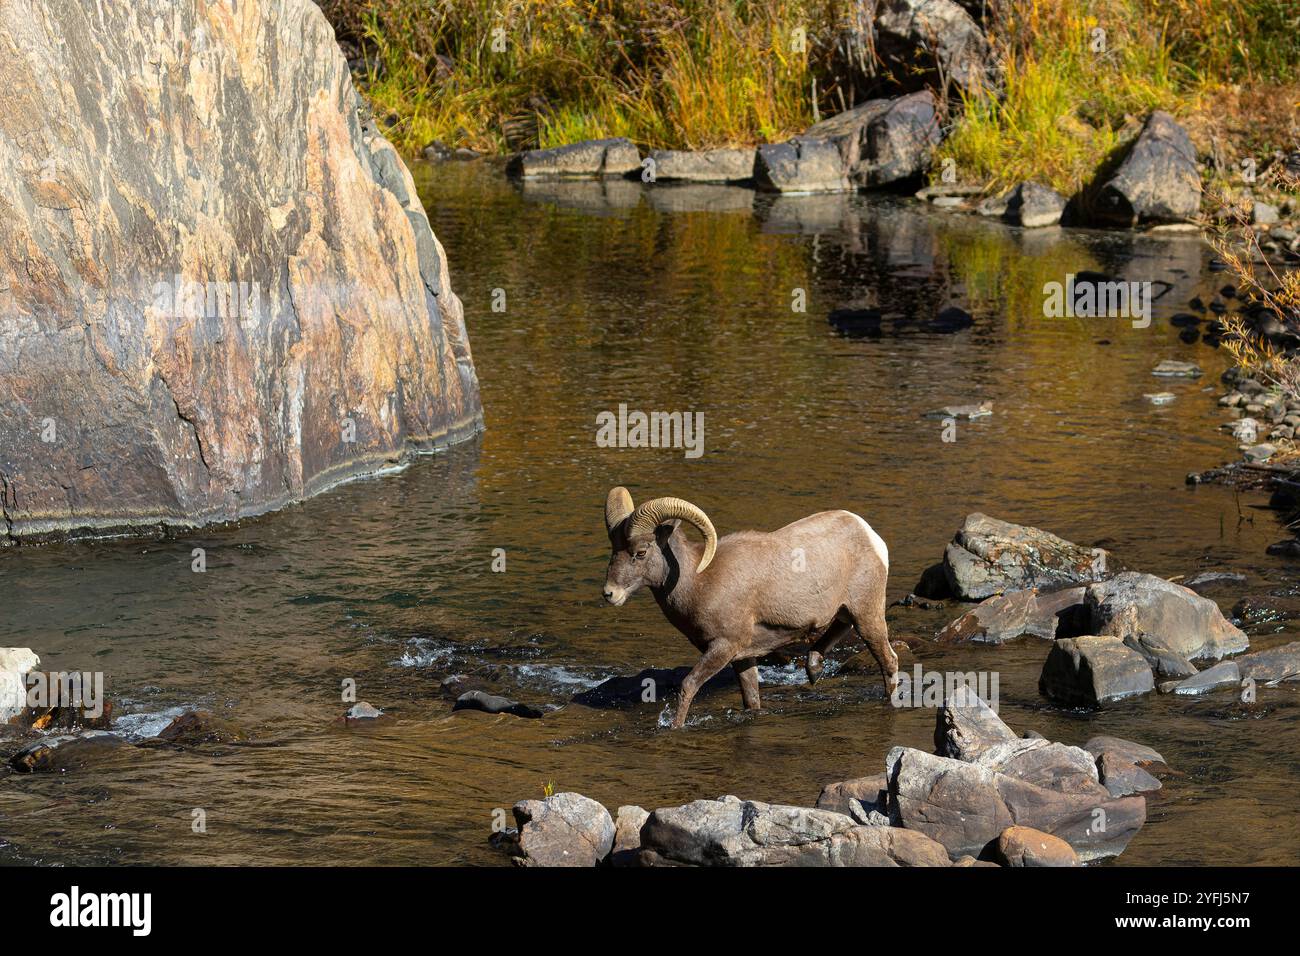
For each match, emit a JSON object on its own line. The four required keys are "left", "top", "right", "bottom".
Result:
{"left": 944, "top": 512, "right": 1109, "bottom": 601}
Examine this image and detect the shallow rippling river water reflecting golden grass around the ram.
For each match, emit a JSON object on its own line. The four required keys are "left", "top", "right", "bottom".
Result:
{"left": 0, "top": 164, "right": 1300, "bottom": 865}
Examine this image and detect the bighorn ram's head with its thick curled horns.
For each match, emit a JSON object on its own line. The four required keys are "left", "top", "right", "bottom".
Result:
{"left": 605, "top": 486, "right": 718, "bottom": 607}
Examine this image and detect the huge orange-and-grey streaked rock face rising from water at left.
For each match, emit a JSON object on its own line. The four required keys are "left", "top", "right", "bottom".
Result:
{"left": 0, "top": 0, "right": 481, "bottom": 541}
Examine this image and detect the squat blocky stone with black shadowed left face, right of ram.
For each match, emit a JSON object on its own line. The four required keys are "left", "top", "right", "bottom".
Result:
{"left": 1039, "top": 635, "right": 1156, "bottom": 708}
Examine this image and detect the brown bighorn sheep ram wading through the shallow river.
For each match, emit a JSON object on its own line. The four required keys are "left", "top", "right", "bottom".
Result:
{"left": 605, "top": 488, "right": 898, "bottom": 728}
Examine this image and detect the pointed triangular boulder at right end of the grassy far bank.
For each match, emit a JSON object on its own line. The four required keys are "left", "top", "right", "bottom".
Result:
{"left": 1097, "top": 109, "right": 1201, "bottom": 228}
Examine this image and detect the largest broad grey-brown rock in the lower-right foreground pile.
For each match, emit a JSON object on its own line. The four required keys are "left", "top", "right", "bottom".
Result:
{"left": 885, "top": 747, "right": 1147, "bottom": 861}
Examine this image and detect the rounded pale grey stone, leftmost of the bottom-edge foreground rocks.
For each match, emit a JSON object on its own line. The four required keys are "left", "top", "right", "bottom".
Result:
{"left": 514, "top": 793, "right": 615, "bottom": 866}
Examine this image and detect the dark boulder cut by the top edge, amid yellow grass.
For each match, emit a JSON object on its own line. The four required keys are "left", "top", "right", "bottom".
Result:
{"left": 832, "top": 0, "right": 1002, "bottom": 96}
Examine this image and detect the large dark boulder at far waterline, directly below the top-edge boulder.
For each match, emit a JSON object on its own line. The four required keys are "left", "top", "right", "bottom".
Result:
{"left": 803, "top": 90, "right": 943, "bottom": 187}
